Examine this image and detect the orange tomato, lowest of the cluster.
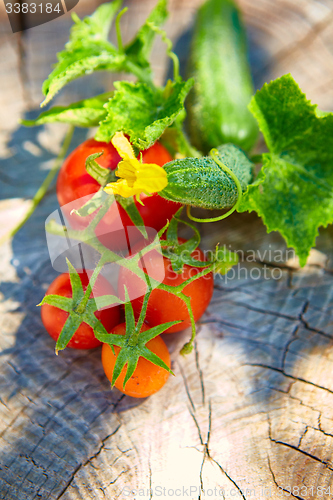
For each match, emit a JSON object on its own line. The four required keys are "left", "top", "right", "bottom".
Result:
{"left": 102, "top": 323, "right": 171, "bottom": 398}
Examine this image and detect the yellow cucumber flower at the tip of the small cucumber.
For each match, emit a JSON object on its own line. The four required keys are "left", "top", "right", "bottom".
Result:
{"left": 104, "top": 132, "right": 168, "bottom": 199}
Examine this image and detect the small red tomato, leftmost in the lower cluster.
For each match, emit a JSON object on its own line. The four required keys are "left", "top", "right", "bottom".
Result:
{"left": 41, "top": 272, "right": 120, "bottom": 349}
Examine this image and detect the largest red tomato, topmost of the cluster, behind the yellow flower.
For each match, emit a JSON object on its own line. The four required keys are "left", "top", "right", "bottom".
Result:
{"left": 57, "top": 139, "right": 181, "bottom": 249}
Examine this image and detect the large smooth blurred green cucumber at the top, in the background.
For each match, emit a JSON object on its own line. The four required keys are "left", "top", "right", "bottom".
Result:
{"left": 187, "top": 0, "right": 258, "bottom": 154}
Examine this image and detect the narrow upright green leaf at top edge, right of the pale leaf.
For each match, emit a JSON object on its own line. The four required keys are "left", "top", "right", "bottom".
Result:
{"left": 125, "top": 0, "right": 168, "bottom": 68}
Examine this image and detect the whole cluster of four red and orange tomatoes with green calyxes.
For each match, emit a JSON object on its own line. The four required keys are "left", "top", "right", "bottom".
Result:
{"left": 41, "top": 139, "right": 213, "bottom": 397}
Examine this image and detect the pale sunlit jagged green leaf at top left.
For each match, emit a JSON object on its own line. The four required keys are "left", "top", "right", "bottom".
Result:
{"left": 41, "top": 0, "right": 126, "bottom": 106}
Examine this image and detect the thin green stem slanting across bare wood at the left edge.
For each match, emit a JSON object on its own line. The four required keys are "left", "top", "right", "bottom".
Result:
{"left": 0, "top": 125, "right": 75, "bottom": 245}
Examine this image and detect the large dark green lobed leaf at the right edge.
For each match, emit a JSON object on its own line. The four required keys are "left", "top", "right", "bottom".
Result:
{"left": 239, "top": 75, "right": 333, "bottom": 266}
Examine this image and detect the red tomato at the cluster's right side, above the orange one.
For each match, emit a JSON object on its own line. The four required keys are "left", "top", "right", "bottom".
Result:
{"left": 118, "top": 238, "right": 214, "bottom": 333}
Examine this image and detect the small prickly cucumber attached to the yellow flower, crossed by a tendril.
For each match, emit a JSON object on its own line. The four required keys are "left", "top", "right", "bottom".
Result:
{"left": 158, "top": 144, "right": 254, "bottom": 209}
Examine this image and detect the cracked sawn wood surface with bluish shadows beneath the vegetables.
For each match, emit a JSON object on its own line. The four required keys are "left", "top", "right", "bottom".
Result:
{"left": 0, "top": 0, "right": 333, "bottom": 500}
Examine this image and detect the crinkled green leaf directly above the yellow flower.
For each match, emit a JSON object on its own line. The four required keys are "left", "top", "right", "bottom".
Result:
{"left": 95, "top": 78, "right": 193, "bottom": 149}
